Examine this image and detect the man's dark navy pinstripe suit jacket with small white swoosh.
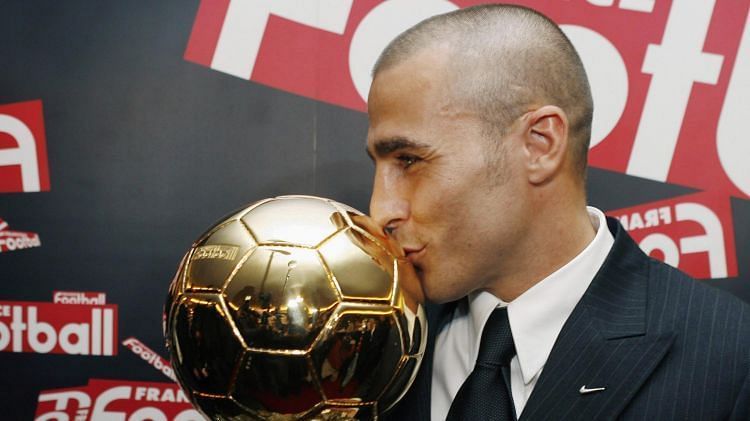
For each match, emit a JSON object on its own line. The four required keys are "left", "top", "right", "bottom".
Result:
{"left": 386, "top": 219, "right": 750, "bottom": 421}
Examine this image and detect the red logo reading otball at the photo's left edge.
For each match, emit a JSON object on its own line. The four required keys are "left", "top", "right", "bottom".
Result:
{"left": 0, "top": 291, "right": 117, "bottom": 356}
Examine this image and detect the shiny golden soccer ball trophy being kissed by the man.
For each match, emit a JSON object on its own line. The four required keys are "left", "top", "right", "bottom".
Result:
{"left": 164, "top": 196, "right": 427, "bottom": 420}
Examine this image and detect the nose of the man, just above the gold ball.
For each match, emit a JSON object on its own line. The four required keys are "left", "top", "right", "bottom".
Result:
{"left": 370, "top": 170, "right": 410, "bottom": 234}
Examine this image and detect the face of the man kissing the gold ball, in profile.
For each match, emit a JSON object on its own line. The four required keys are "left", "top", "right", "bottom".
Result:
{"left": 367, "top": 50, "right": 529, "bottom": 302}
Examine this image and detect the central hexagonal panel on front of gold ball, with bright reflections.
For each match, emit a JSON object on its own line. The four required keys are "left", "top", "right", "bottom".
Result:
{"left": 225, "top": 246, "right": 338, "bottom": 350}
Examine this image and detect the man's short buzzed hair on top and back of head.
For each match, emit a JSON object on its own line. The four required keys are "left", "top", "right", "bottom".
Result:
{"left": 373, "top": 4, "right": 594, "bottom": 181}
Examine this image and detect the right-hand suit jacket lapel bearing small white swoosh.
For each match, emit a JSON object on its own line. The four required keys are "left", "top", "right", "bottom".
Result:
{"left": 521, "top": 220, "right": 674, "bottom": 420}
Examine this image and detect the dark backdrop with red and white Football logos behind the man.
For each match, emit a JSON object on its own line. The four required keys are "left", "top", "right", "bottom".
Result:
{"left": 0, "top": 0, "right": 750, "bottom": 421}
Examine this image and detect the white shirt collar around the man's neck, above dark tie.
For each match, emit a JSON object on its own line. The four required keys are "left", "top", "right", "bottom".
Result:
{"left": 469, "top": 207, "right": 614, "bottom": 384}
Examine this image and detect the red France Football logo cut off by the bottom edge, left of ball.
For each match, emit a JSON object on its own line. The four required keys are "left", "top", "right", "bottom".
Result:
{"left": 34, "top": 379, "right": 204, "bottom": 421}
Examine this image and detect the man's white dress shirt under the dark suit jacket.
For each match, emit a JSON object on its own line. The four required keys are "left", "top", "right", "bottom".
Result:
{"left": 431, "top": 207, "right": 614, "bottom": 420}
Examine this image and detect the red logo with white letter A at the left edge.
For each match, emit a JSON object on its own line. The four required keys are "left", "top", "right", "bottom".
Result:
{"left": 0, "top": 100, "right": 50, "bottom": 193}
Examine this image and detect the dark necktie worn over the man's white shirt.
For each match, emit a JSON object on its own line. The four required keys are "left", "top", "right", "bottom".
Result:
{"left": 446, "top": 307, "right": 516, "bottom": 421}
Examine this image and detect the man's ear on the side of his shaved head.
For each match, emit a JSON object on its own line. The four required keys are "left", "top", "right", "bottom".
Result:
{"left": 523, "top": 105, "right": 568, "bottom": 184}
